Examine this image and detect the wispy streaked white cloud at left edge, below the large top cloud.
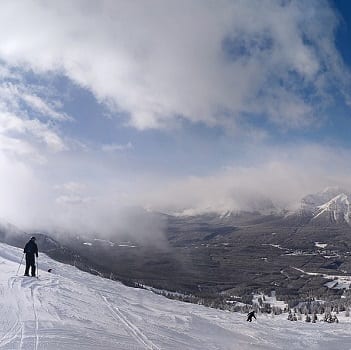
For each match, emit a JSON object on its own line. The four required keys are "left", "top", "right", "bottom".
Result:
{"left": 0, "top": 63, "right": 72, "bottom": 162}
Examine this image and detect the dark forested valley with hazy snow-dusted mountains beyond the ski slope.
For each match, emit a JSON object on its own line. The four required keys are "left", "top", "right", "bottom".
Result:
{"left": 0, "top": 187, "right": 351, "bottom": 298}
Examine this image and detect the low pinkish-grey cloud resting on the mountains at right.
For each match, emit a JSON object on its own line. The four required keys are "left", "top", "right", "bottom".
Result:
{"left": 137, "top": 144, "right": 351, "bottom": 213}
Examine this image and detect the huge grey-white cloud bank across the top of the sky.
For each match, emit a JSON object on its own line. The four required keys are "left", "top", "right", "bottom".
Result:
{"left": 0, "top": 0, "right": 349, "bottom": 129}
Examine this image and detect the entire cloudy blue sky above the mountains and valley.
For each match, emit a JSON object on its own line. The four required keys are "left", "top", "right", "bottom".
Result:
{"left": 0, "top": 0, "right": 351, "bottom": 233}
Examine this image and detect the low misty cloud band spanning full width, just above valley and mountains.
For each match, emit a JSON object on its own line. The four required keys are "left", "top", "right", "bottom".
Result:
{"left": 0, "top": 137, "right": 351, "bottom": 236}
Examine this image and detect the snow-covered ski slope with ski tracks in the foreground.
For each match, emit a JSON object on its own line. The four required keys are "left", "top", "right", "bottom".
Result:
{"left": 0, "top": 244, "right": 351, "bottom": 350}
